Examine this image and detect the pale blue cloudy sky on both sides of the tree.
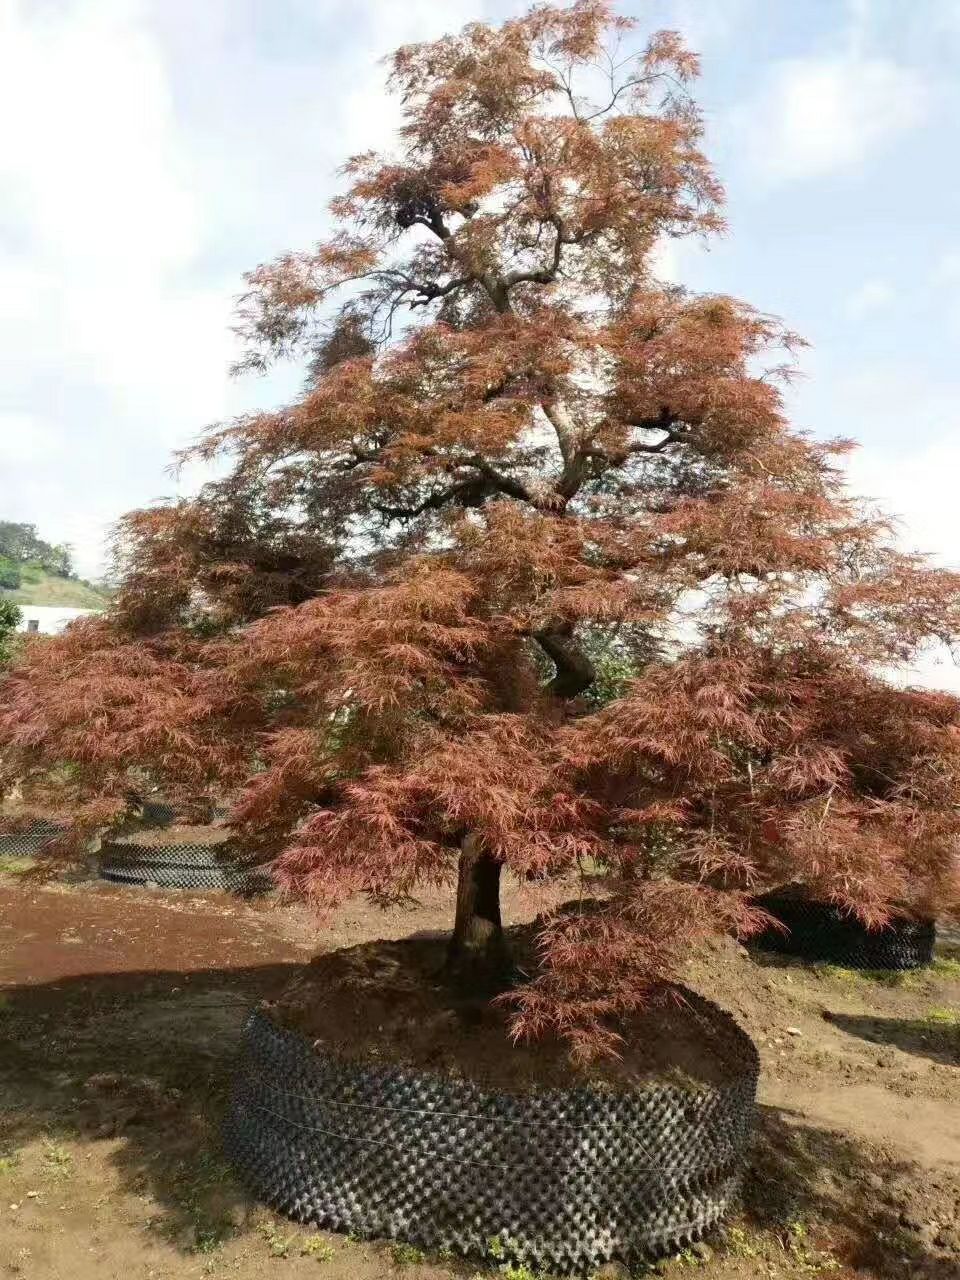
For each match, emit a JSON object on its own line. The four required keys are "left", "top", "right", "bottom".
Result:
{"left": 0, "top": 0, "right": 960, "bottom": 682}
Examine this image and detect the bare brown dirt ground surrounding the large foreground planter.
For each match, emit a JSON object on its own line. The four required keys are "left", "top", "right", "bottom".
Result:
{"left": 0, "top": 874, "right": 960, "bottom": 1280}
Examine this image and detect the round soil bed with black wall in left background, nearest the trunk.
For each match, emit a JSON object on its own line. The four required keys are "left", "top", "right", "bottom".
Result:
{"left": 100, "top": 827, "right": 271, "bottom": 893}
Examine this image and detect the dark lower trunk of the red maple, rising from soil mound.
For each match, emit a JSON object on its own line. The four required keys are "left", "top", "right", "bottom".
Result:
{"left": 447, "top": 835, "right": 509, "bottom": 987}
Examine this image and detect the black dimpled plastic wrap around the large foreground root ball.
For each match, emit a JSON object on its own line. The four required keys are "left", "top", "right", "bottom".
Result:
{"left": 224, "top": 992, "right": 759, "bottom": 1272}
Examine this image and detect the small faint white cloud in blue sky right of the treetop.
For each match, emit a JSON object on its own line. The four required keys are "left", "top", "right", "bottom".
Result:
{"left": 733, "top": 52, "right": 931, "bottom": 182}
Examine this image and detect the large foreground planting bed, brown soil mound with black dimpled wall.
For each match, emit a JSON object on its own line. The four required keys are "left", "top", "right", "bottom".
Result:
{"left": 225, "top": 940, "right": 758, "bottom": 1271}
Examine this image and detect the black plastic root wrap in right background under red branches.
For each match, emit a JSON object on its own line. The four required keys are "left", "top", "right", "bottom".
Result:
{"left": 750, "top": 892, "right": 937, "bottom": 969}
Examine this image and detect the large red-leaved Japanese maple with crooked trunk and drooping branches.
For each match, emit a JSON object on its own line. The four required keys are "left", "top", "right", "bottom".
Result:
{"left": 0, "top": 0, "right": 960, "bottom": 1057}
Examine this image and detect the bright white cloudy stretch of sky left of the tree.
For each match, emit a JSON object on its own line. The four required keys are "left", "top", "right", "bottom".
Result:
{"left": 0, "top": 0, "right": 483, "bottom": 573}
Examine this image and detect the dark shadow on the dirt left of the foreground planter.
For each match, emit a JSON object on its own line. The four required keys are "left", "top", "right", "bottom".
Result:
{"left": 0, "top": 963, "right": 298, "bottom": 1251}
